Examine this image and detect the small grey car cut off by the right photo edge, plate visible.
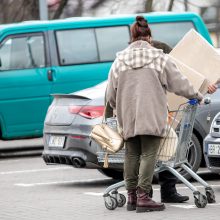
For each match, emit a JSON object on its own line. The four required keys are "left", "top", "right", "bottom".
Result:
{"left": 203, "top": 112, "right": 220, "bottom": 174}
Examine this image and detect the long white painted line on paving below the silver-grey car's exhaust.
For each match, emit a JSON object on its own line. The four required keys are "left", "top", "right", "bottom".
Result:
{"left": 14, "top": 178, "right": 110, "bottom": 187}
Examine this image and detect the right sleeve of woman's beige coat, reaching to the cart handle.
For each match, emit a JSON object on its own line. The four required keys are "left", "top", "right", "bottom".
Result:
{"left": 161, "top": 58, "right": 203, "bottom": 101}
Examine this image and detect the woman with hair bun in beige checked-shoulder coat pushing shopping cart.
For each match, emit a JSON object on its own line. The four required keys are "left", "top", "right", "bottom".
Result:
{"left": 106, "top": 16, "right": 202, "bottom": 212}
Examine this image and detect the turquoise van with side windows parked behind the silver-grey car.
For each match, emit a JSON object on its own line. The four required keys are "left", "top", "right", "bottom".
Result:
{"left": 0, "top": 13, "right": 211, "bottom": 139}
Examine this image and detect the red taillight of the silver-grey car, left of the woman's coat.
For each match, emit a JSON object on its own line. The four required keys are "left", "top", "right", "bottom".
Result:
{"left": 69, "top": 106, "right": 104, "bottom": 119}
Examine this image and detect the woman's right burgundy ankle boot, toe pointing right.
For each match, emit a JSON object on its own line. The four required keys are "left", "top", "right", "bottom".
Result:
{"left": 136, "top": 188, "right": 165, "bottom": 212}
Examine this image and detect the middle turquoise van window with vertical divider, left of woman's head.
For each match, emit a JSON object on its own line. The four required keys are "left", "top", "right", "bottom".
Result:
{"left": 56, "top": 26, "right": 130, "bottom": 65}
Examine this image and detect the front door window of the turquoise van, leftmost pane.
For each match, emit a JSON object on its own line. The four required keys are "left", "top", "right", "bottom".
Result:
{"left": 0, "top": 36, "right": 45, "bottom": 70}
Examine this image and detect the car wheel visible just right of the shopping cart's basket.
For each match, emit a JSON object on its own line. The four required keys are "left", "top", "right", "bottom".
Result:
{"left": 179, "top": 134, "right": 202, "bottom": 179}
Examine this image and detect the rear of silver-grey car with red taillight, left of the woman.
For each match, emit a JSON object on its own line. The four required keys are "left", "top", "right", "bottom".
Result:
{"left": 43, "top": 81, "right": 122, "bottom": 179}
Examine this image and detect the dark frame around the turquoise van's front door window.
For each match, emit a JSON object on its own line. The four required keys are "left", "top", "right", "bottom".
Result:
{"left": 0, "top": 31, "right": 49, "bottom": 72}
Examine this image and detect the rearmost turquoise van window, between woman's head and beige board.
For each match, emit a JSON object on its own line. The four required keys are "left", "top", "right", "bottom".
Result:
{"left": 150, "top": 22, "right": 195, "bottom": 47}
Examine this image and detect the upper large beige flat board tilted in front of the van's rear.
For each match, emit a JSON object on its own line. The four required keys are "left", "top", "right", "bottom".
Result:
{"left": 170, "top": 29, "right": 220, "bottom": 83}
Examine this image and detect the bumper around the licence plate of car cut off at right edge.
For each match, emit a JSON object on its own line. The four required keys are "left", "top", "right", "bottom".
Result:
{"left": 203, "top": 134, "right": 220, "bottom": 174}
